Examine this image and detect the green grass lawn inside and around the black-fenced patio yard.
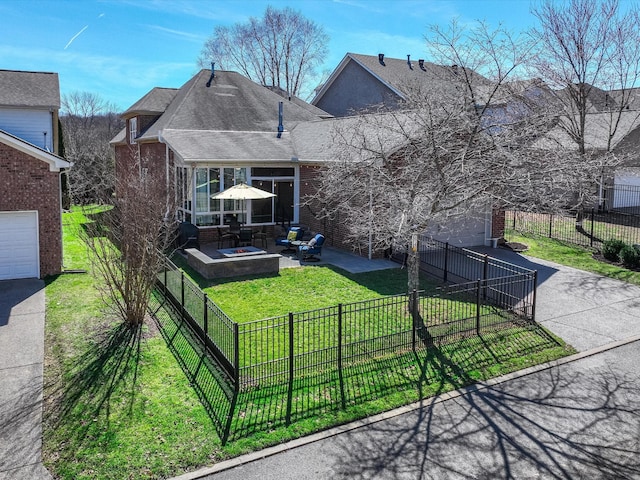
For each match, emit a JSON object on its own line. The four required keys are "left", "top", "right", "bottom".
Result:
{"left": 43, "top": 211, "right": 573, "bottom": 479}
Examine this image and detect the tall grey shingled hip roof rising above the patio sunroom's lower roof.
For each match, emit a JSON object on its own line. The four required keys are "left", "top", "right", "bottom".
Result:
{"left": 139, "top": 70, "right": 330, "bottom": 140}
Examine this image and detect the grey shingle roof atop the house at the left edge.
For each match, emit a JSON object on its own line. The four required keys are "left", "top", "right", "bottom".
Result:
{"left": 0, "top": 70, "right": 60, "bottom": 109}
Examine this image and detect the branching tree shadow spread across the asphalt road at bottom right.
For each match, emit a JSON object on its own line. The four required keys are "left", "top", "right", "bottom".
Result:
{"left": 328, "top": 342, "right": 640, "bottom": 479}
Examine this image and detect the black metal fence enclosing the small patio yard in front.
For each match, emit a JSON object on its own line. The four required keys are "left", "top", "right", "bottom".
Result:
{"left": 158, "top": 246, "right": 536, "bottom": 390}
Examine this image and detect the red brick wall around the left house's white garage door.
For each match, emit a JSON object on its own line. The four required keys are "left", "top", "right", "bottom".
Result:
{"left": 0, "top": 143, "right": 62, "bottom": 277}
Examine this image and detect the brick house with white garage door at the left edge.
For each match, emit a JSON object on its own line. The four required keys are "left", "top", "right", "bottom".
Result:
{"left": 0, "top": 70, "right": 69, "bottom": 280}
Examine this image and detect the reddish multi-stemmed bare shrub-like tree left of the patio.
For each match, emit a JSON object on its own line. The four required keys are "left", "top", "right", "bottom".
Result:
{"left": 84, "top": 149, "right": 175, "bottom": 328}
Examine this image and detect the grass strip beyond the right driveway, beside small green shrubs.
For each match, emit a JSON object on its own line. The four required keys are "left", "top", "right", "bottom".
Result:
{"left": 505, "top": 230, "right": 640, "bottom": 285}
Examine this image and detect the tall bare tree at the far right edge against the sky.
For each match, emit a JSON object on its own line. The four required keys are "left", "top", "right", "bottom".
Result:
{"left": 531, "top": 0, "right": 640, "bottom": 218}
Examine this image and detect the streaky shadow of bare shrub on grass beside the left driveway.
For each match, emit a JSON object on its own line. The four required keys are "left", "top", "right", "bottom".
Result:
{"left": 43, "top": 322, "right": 143, "bottom": 460}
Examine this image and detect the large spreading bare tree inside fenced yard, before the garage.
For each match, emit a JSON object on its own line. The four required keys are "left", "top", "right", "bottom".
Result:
{"left": 314, "top": 22, "right": 616, "bottom": 291}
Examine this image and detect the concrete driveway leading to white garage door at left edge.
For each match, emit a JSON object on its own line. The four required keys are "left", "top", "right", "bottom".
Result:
{"left": 0, "top": 279, "right": 52, "bottom": 480}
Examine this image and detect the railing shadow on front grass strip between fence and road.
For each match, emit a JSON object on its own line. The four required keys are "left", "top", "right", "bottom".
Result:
{"left": 229, "top": 326, "right": 558, "bottom": 440}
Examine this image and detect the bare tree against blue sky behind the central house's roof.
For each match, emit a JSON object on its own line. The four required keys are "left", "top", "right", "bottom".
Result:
{"left": 198, "top": 6, "right": 329, "bottom": 96}
